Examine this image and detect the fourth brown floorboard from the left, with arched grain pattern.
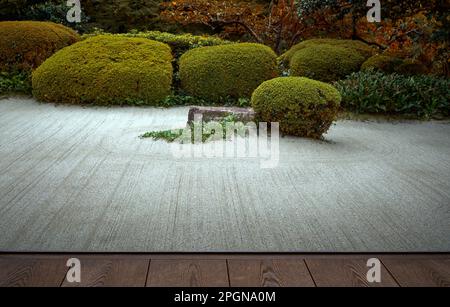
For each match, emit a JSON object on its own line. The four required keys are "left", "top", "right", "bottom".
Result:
{"left": 228, "top": 259, "right": 314, "bottom": 287}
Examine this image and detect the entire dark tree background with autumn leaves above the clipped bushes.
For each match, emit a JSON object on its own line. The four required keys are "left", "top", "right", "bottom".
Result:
{"left": 0, "top": 0, "right": 450, "bottom": 76}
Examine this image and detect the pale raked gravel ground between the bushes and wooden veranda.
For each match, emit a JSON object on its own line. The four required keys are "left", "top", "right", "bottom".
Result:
{"left": 0, "top": 98, "right": 450, "bottom": 252}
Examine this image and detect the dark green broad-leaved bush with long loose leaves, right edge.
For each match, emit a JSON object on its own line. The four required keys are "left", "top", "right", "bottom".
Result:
{"left": 335, "top": 71, "right": 450, "bottom": 117}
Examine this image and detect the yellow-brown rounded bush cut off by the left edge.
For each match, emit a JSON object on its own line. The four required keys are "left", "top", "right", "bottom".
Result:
{"left": 0, "top": 21, "right": 80, "bottom": 72}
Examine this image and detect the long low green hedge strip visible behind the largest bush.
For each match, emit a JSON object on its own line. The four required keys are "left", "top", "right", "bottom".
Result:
{"left": 83, "top": 31, "right": 233, "bottom": 58}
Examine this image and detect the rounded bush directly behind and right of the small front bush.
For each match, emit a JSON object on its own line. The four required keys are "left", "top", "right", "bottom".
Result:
{"left": 290, "top": 45, "right": 364, "bottom": 82}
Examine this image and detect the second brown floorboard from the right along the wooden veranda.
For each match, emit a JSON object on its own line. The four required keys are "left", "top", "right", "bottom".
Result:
{"left": 305, "top": 257, "right": 398, "bottom": 287}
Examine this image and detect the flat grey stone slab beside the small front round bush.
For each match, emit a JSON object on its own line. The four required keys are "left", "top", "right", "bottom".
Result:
{"left": 188, "top": 107, "right": 255, "bottom": 124}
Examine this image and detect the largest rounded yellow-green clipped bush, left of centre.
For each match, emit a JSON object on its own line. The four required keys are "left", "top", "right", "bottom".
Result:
{"left": 32, "top": 35, "right": 172, "bottom": 105}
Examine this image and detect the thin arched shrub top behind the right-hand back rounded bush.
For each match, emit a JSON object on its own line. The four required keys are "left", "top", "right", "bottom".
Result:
{"left": 279, "top": 38, "right": 375, "bottom": 67}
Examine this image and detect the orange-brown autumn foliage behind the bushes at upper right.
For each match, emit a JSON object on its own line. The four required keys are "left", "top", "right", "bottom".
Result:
{"left": 161, "top": 0, "right": 450, "bottom": 74}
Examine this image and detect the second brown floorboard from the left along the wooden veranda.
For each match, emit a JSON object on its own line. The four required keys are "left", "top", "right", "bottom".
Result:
{"left": 62, "top": 257, "right": 150, "bottom": 287}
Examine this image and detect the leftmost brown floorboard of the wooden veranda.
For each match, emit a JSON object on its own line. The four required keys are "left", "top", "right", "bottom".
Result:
{"left": 0, "top": 257, "right": 68, "bottom": 287}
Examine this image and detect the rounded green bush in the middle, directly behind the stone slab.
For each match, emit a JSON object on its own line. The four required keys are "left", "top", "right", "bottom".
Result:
{"left": 179, "top": 43, "right": 277, "bottom": 101}
